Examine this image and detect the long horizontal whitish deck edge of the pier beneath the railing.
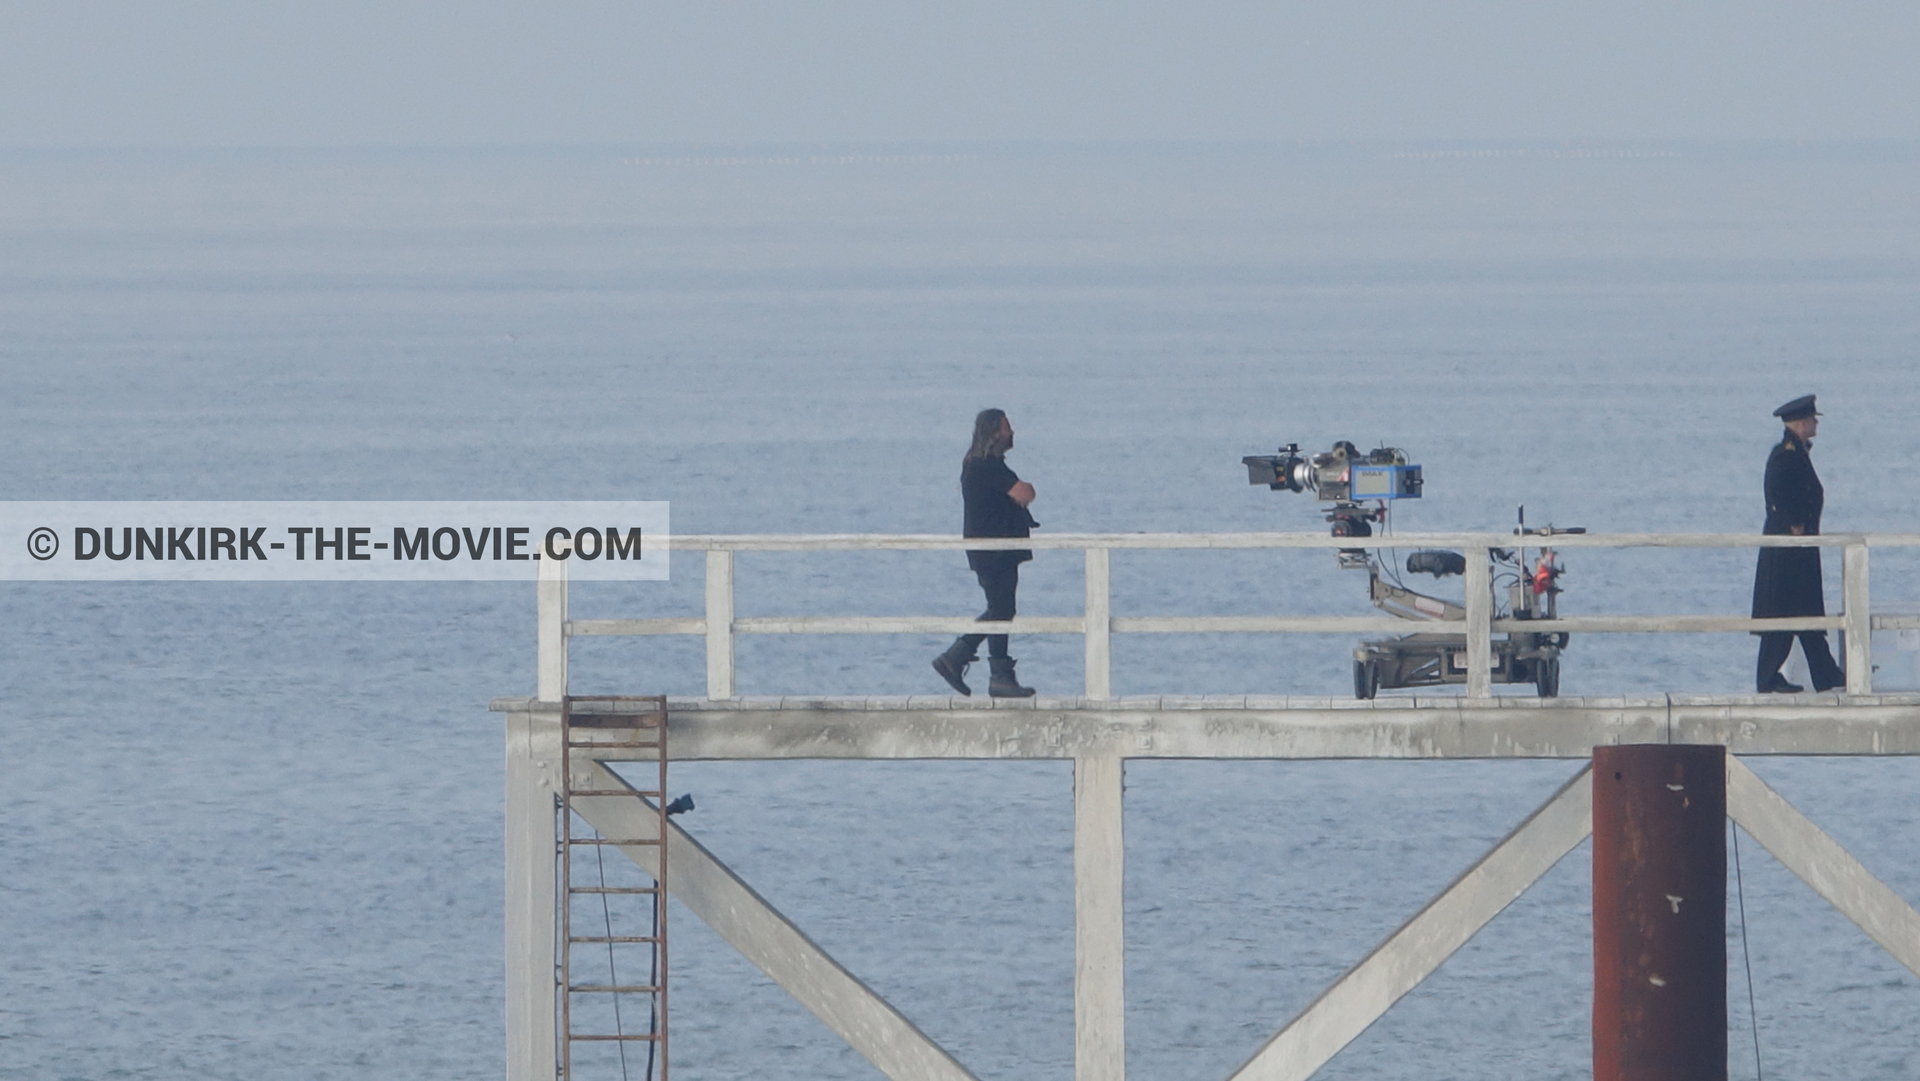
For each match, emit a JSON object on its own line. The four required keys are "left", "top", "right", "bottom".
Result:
{"left": 493, "top": 691, "right": 1920, "bottom": 760}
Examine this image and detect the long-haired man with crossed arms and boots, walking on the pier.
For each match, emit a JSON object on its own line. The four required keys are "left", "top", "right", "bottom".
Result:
{"left": 933, "top": 409, "right": 1039, "bottom": 699}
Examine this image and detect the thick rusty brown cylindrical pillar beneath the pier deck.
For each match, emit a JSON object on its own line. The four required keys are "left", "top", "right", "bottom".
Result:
{"left": 1594, "top": 743, "right": 1726, "bottom": 1081}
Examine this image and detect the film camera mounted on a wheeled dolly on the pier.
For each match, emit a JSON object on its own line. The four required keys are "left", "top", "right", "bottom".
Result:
{"left": 1240, "top": 442, "right": 1586, "bottom": 699}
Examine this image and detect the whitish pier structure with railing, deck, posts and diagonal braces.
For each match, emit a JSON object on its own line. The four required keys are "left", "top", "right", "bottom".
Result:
{"left": 493, "top": 534, "right": 1920, "bottom": 1081}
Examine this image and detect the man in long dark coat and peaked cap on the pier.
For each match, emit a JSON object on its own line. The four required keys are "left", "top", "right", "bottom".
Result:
{"left": 1753, "top": 394, "right": 1847, "bottom": 695}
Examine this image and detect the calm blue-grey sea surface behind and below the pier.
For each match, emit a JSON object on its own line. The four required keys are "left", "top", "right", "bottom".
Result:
{"left": 0, "top": 144, "right": 1920, "bottom": 1081}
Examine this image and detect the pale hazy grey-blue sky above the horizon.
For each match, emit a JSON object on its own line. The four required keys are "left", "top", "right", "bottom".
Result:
{"left": 0, "top": 0, "right": 1920, "bottom": 148}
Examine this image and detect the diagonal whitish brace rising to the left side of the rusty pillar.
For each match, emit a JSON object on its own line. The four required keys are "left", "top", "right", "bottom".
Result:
{"left": 1231, "top": 768, "right": 1594, "bottom": 1081}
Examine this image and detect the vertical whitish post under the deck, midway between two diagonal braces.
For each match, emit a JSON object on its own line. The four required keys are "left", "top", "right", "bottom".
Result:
{"left": 1073, "top": 755, "right": 1127, "bottom": 1081}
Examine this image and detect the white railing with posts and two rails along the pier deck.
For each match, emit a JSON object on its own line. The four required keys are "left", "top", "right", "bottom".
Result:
{"left": 540, "top": 534, "right": 1920, "bottom": 699}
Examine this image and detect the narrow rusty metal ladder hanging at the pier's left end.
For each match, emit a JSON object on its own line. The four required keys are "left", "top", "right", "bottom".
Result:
{"left": 555, "top": 695, "right": 668, "bottom": 1081}
